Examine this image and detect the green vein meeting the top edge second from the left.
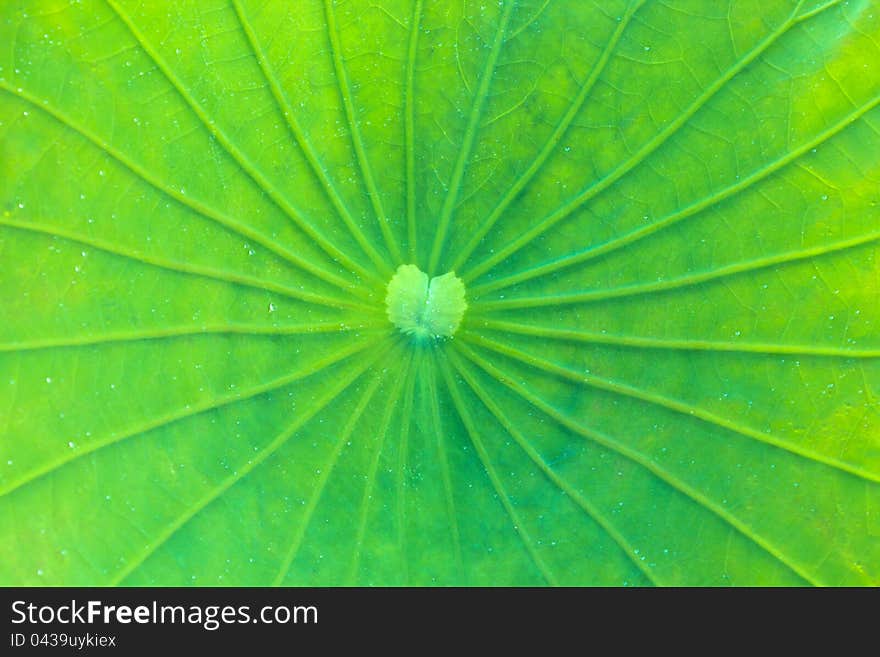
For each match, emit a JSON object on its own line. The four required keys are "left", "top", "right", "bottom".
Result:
{"left": 232, "top": 0, "right": 390, "bottom": 274}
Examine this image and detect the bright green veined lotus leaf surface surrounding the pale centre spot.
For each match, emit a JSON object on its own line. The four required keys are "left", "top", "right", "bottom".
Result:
{"left": 0, "top": 0, "right": 880, "bottom": 585}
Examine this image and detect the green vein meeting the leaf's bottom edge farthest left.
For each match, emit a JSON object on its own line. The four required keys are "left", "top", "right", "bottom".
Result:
{"left": 109, "top": 343, "right": 390, "bottom": 586}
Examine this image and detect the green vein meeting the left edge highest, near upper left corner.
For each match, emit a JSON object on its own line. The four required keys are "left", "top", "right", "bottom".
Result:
{"left": 0, "top": 80, "right": 374, "bottom": 296}
